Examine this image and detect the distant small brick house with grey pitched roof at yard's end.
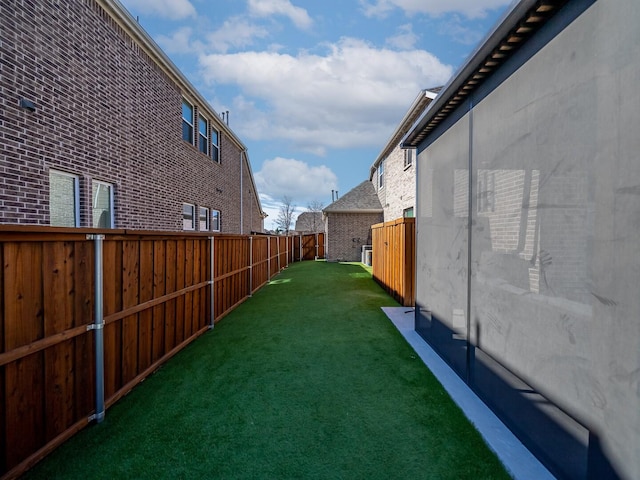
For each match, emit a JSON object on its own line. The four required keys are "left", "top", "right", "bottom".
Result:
{"left": 323, "top": 180, "right": 383, "bottom": 262}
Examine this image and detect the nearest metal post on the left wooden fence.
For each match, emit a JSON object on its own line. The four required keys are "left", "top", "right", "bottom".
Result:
{"left": 87, "top": 235, "right": 105, "bottom": 423}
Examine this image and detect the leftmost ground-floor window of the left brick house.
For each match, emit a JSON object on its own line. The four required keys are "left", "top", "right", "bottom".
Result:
{"left": 49, "top": 170, "right": 80, "bottom": 227}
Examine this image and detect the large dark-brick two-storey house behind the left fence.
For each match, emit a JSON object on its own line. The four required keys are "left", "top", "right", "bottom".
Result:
{"left": 0, "top": 0, "right": 265, "bottom": 233}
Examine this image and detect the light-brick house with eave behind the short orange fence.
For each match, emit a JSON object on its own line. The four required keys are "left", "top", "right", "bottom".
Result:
{"left": 369, "top": 87, "right": 441, "bottom": 222}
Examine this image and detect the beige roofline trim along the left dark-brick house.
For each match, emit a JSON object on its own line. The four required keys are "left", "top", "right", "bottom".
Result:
{"left": 97, "top": 0, "right": 267, "bottom": 219}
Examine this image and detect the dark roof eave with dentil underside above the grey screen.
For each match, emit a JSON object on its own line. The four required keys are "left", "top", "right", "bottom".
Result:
{"left": 401, "top": 0, "right": 568, "bottom": 148}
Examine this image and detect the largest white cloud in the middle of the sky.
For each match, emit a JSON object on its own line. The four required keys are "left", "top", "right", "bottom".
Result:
{"left": 200, "top": 38, "right": 452, "bottom": 154}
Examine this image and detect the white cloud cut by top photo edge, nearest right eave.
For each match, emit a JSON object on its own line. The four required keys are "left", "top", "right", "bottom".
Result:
{"left": 360, "top": 0, "right": 511, "bottom": 18}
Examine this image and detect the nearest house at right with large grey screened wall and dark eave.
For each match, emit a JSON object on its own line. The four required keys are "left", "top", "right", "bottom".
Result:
{"left": 403, "top": 0, "right": 640, "bottom": 479}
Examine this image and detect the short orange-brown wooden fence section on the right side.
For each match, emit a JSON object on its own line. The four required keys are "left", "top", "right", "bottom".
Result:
{"left": 371, "top": 218, "right": 416, "bottom": 306}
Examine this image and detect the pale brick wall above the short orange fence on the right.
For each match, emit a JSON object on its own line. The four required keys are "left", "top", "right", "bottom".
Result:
{"left": 371, "top": 145, "right": 416, "bottom": 222}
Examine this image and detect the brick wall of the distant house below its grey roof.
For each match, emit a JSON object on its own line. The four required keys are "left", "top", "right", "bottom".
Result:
{"left": 325, "top": 213, "right": 383, "bottom": 262}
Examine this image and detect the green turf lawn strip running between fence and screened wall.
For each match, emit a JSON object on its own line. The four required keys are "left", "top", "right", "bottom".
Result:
{"left": 27, "top": 262, "right": 509, "bottom": 480}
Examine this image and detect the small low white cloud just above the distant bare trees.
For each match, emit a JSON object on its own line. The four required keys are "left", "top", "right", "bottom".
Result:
{"left": 254, "top": 157, "right": 338, "bottom": 203}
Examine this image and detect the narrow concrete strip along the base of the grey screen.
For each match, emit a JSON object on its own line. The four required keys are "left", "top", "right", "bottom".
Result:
{"left": 382, "top": 307, "right": 555, "bottom": 480}
